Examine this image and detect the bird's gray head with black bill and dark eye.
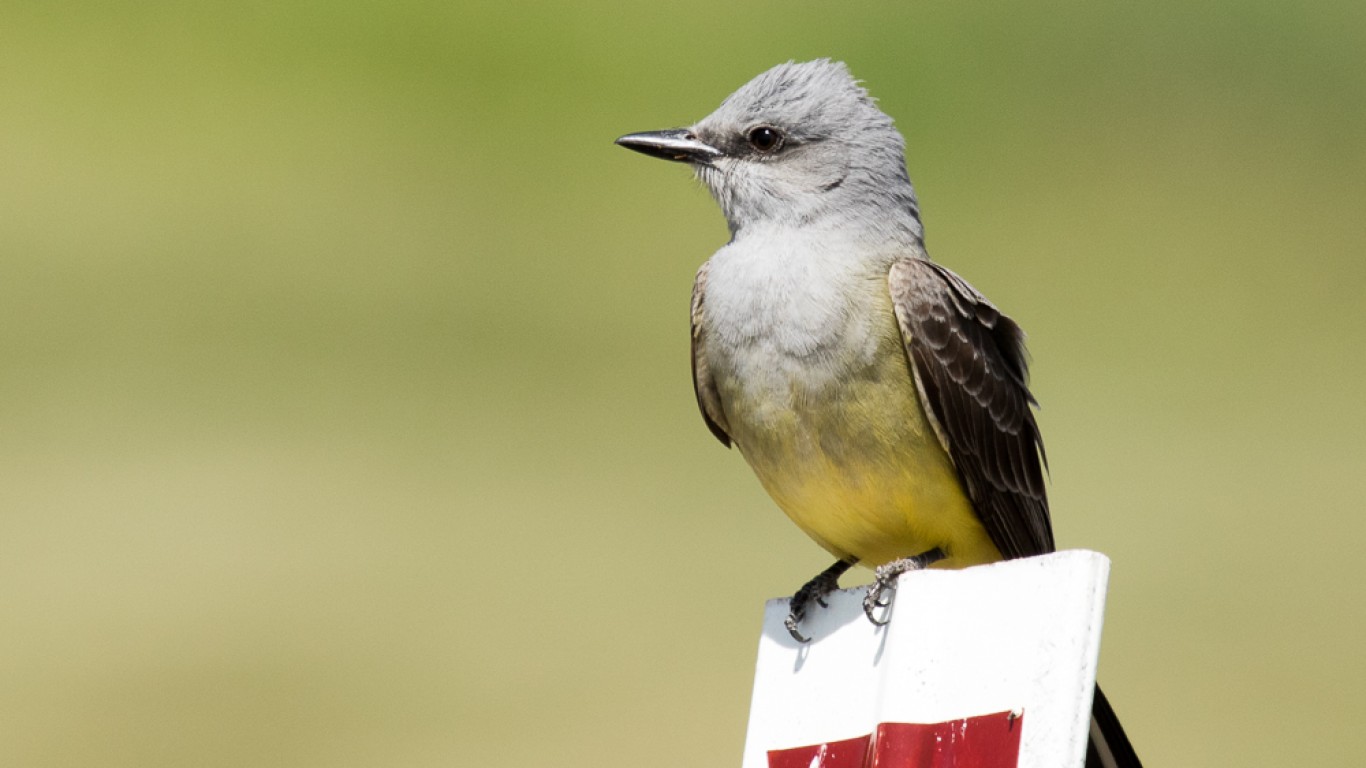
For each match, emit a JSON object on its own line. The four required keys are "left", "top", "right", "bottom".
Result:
{"left": 616, "top": 59, "right": 922, "bottom": 241}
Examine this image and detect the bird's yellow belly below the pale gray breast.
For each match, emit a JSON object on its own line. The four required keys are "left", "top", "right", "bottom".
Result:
{"left": 721, "top": 330, "right": 1001, "bottom": 568}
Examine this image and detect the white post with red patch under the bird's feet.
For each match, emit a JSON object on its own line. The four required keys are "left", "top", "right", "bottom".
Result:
{"left": 743, "top": 551, "right": 1109, "bottom": 768}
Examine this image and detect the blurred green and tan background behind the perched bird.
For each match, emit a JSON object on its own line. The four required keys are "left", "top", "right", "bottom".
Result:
{"left": 0, "top": 0, "right": 1366, "bottom": 767}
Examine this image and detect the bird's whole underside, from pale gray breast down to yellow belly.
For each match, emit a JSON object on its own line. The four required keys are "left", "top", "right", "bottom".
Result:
{"left": 701, "top": 236, "right": 994, "bottom": 566}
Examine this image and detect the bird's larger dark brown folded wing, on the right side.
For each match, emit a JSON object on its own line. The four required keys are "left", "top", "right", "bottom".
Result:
{"left": 888, "top": 258, "right": 1053, "bottom": 558}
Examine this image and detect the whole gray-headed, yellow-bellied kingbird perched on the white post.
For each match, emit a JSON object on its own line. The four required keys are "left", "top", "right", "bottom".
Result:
{"left": 617, "top": 59, "right": 1139, "bottom": 767}
